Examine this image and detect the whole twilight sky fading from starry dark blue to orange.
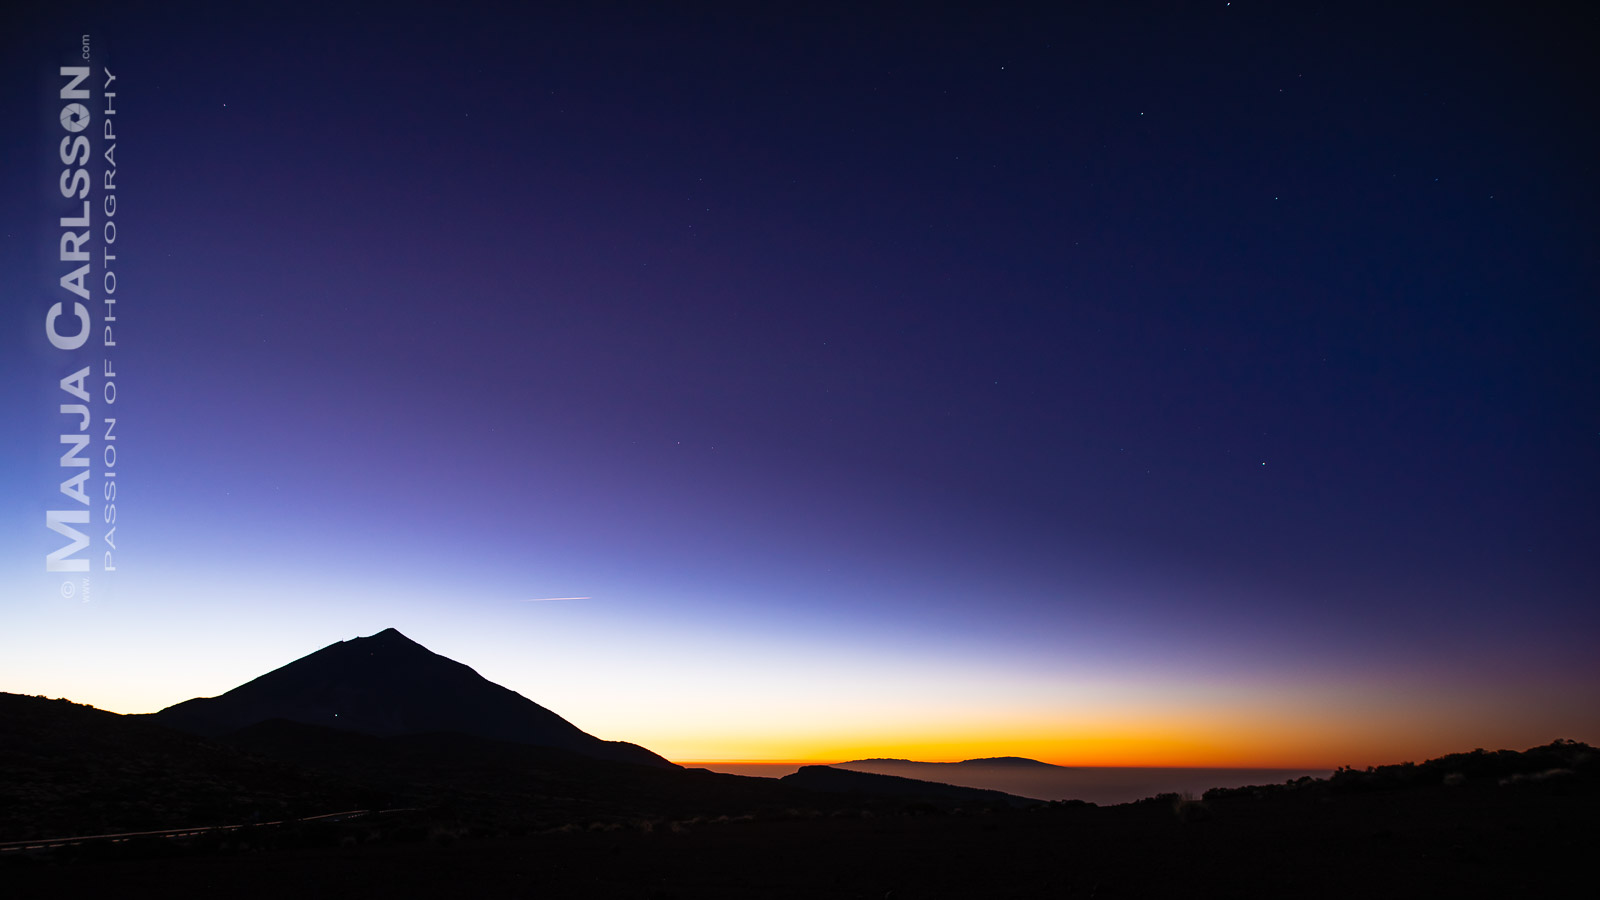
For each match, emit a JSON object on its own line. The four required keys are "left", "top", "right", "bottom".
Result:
{"left": 0, "top": 2, "right": 1600, "bottom": 767}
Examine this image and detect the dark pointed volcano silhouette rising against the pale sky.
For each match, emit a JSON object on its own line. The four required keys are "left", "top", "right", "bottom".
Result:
{"left": 152, "top": 628, "right": 677, "bottom": 769}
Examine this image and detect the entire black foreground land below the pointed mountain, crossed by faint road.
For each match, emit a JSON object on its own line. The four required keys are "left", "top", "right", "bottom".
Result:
{"left": 0, "top": 693, "right": 1600, "bottom": 900}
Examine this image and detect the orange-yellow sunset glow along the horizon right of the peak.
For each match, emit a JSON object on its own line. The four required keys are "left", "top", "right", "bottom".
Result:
{"left": 606, "top": 656, "right": 1597, "bottom": 770}
